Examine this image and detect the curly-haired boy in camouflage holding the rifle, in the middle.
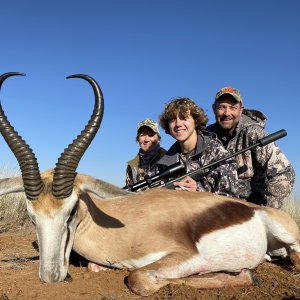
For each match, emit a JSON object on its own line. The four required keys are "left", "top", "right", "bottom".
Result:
{"left": 157, "top": 98, "right": 237, "bottom": 196}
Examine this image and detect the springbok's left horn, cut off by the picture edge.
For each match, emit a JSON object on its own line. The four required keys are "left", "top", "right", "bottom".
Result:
{"left": 0, "top": 72, "right": 44, "bottom": 200}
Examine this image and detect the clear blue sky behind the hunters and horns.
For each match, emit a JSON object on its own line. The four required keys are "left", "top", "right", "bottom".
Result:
{"left": 0, "top": 0, "right": 300, "bottom": 192}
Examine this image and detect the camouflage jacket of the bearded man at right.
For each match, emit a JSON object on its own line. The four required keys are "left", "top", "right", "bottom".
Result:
{"left": 207, "top": 109, "right": 295, "bottom": 208}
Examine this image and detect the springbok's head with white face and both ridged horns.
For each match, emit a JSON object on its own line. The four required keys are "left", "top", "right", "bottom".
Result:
{"left": 0, "top": 72, "right": 104, "bottom": 282}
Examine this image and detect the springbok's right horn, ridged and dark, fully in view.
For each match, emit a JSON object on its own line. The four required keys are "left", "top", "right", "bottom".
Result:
{"left": 52, "top": 74, "right": 104, "bottom": 199}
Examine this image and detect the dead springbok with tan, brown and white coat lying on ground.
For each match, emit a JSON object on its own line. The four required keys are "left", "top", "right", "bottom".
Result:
{"left": 0, "top": 72, "right": 300, "bottom": 296}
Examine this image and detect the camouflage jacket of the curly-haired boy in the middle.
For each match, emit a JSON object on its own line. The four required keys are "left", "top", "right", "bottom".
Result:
{"left": 157, "top": 131, "right": 238, "bottom": 196}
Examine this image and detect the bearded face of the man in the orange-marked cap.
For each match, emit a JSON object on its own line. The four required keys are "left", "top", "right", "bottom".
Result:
{"left": 213, "top": 95, "right": 243, "bottom": 132}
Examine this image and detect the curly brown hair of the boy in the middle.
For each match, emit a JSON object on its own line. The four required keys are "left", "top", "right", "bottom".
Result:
{"left": 159, "top": 97, "right": 208, "bottom": 134}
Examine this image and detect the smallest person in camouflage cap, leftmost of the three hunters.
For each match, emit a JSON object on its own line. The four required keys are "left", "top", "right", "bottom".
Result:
{"left": 126, "top": 118, "right": 166, "bottom": 185}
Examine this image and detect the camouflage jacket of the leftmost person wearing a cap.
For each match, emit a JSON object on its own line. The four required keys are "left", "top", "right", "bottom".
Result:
{"left": 125, "top": 147, "right": 166, "bottom": 185}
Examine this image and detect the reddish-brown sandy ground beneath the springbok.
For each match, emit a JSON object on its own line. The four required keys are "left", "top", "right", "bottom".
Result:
{"left": 0, "top": 227, "right": 300, "bottom": 300}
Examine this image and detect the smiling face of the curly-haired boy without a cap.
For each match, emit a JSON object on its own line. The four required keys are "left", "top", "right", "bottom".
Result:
{"left": 169, "top": 114, "right": 197, "bottom": 143}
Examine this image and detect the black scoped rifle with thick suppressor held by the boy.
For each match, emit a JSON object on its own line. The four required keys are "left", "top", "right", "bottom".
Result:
{"left": 123, "top": 129, "right": 287, "bottom": 192}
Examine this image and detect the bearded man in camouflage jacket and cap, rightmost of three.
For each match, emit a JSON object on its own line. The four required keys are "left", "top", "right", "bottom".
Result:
{"left": 207, "top": 87, "right": 295, "bottom": 208}
